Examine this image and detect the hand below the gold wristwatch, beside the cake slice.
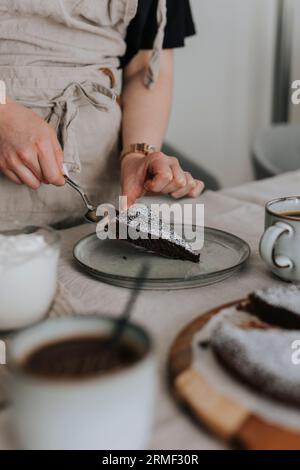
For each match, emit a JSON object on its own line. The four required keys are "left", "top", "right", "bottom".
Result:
{"left": 121, "top": 152, "right": 204, "bottom": 207}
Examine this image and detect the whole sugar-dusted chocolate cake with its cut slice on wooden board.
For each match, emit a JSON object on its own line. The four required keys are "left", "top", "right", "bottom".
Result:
{"left": 210, "top": 285, "right": 300, "bottom": 405}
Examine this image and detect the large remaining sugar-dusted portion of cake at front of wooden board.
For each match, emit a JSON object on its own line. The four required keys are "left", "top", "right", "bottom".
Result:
{"left": 210, "top": 310, "right": 300, "bottom": 405}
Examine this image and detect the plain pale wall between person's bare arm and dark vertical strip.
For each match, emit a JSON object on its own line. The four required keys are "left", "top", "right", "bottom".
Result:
{"left": 167, "top": 0, "right": 276, "bottom": 187}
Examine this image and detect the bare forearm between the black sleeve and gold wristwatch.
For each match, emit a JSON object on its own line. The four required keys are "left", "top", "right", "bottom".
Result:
{"left": 122, "top": 50, "right": 173, "bottom": 150}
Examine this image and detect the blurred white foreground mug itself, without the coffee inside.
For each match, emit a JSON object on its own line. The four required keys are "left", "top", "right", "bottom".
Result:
{"left": 8, "top": 315, "right": 156, "bottom": 450}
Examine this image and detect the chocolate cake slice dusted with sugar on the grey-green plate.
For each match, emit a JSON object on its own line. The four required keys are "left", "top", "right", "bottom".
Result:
{"left": 113, "top": 205, "right": 200, "bottom": 263}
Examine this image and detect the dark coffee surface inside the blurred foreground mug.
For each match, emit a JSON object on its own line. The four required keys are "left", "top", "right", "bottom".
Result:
{"left": 22, "top": 336, "right": 144, "bottom": 379}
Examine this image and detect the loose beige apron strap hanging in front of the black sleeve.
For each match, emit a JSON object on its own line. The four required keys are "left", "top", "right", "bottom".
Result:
{"left": 144, "top": 0, "right": 167, "bottom": 88}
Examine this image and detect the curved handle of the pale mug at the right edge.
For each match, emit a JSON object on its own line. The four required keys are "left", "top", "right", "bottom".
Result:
{"left": 259, "top": 222, "right": 293, "bottom": 269}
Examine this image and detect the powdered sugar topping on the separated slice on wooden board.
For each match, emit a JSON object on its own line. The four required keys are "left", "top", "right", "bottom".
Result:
{"left": 254, "top": 285, "right": 300, "bottom": 315}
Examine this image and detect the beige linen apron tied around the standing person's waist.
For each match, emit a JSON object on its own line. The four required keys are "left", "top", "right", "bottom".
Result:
{"left": 0, "top": 0, "right": 166, "bottom": 224}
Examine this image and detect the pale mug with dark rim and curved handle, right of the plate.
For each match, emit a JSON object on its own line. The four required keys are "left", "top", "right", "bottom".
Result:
{"left": 259, "top": 196, "right": 300, "bottom": 281}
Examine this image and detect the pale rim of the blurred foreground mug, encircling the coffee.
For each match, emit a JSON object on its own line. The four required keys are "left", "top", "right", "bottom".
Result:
{"left": 7, "top": 313, "right": 154, "bottom": 386}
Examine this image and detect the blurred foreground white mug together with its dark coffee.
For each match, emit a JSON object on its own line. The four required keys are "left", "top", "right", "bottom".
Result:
{"left": 8, "top": 316, "right": 156, "bottom": 450}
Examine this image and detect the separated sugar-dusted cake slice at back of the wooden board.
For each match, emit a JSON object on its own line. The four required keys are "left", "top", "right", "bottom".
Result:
{"left": 245, "top": 285, "right": 300, "bottom": 330}
